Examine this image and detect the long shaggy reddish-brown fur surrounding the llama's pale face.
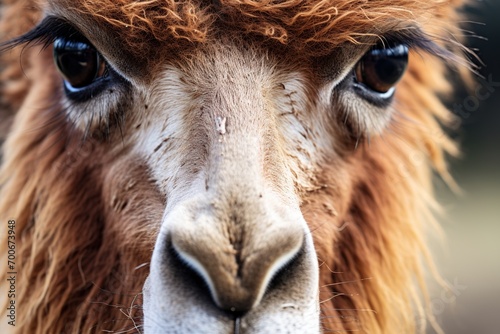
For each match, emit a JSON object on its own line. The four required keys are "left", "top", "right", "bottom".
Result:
{"left": 0, "top": 0, "right": 468, "bottom": 334}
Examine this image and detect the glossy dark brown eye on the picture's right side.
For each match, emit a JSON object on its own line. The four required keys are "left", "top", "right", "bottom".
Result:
{"left": 355, "top": 44, "right": 408, "bottom": 94}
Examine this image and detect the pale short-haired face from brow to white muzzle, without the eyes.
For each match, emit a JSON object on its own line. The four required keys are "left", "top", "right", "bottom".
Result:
{"left": 53, "top": 21, "right": 334, "bottom": 333}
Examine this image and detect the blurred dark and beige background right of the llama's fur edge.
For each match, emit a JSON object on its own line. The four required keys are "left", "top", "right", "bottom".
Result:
{"left": 429, "top": 0, "right": 500, "bottom": 334}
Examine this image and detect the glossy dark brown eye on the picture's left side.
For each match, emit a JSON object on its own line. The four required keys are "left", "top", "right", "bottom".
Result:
{"left": 54, "top": 38, "right": 106, "bottom": 88}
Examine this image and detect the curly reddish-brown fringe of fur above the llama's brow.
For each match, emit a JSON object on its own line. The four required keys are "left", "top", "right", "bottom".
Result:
{"left": 49, "top": 0, "right": 450, "bottom": 53}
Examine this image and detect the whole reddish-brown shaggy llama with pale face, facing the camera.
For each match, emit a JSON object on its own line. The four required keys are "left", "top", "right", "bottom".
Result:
{"left": 0, "top": 0, "right": 463, "bottom": 334}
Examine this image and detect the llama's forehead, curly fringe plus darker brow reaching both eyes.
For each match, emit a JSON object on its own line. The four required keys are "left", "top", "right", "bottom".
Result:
{"left": 47, "top": 0, "right": 454, "bottom": 81}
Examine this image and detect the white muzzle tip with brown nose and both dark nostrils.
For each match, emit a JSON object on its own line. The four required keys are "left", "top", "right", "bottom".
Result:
{"left": 144, "top": 194, "right": 320, "bottom": 334}
